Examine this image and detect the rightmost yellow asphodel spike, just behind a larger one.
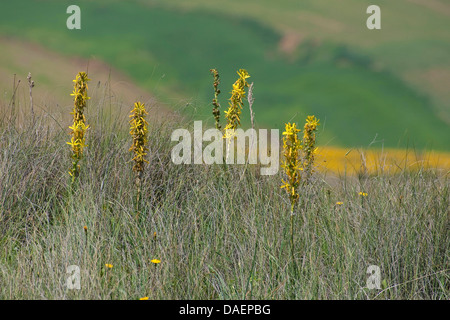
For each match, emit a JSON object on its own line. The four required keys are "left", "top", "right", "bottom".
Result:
{"left": 303, "top": 116, "right": 319, "bottom": 181}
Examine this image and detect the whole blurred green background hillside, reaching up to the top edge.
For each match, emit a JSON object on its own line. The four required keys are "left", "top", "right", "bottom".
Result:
{"left": 0, "top": 0, "right": 450, "bottom": 150}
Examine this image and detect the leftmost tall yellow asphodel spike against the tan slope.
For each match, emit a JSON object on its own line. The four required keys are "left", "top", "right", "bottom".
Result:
{"left": 67, "top": 72, "right": 89, "bottom": 182}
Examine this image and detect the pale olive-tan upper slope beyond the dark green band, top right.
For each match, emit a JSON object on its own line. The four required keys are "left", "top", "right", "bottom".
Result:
{"left": 148, "top": 0, "right": 450, "bottom": 124}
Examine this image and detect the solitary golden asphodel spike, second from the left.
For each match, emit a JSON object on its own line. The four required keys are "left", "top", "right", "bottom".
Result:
{"left": 129, "top": 102, "right": 148, "bottom": 211}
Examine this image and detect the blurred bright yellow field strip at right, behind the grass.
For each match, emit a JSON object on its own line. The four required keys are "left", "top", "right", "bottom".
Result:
{"left": 316, "top": 146, "right": 450, "bottom": 175}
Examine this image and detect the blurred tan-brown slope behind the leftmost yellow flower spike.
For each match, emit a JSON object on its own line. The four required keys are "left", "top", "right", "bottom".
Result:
{"left": 0, "top": 37, "right": 172, "bottom": 121}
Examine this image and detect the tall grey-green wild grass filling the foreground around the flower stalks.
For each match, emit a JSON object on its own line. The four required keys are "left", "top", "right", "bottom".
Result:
{"left": 0, "top": 87, "right": 450, "bottom": 299}
